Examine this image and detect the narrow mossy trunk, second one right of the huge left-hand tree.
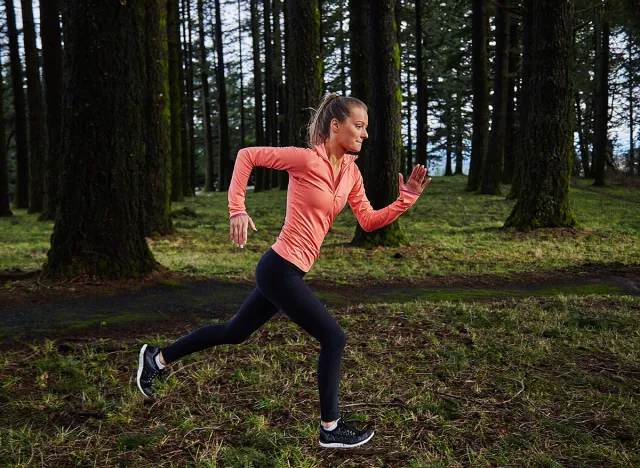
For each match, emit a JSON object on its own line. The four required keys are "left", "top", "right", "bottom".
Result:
{"left": 167, "top": 0, "right": 184, "bottom": 201}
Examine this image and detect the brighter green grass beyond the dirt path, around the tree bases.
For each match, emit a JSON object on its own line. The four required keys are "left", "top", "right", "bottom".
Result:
{"left": 0, "top": 177, "right": 640, "bottom": 284}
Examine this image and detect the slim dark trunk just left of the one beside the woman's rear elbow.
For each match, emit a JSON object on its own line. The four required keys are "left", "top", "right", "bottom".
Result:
{"left": 198, "top": 0, "right": 216, "bottom": 192}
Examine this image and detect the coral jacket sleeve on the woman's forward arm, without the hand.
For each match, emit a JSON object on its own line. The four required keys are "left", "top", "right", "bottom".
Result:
{"left": 349, "top": 166, "right": 420, "bottom": 232}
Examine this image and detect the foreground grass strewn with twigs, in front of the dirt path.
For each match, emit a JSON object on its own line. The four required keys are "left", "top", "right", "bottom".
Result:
{"left": 0, "top": 295, "right": 640, "bottom": 467}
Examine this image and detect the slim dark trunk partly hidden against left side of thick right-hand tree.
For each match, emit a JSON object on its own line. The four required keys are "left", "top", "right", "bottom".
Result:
{"left": 507, "top": 0, "right": 533, "bottom": 200}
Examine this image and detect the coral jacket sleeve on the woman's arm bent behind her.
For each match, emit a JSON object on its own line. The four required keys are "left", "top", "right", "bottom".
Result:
{"left": 228, "top": 146, "right": 311, "bottom": 218}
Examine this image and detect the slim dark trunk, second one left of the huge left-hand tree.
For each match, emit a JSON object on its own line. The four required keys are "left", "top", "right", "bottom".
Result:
{"left": 22, "top": 0, "right": 47, "bottom": 213}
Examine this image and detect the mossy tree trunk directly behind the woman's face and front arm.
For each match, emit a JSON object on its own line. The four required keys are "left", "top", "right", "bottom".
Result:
{"left": 353, "top": 0, "right": 407, "bottom": 248}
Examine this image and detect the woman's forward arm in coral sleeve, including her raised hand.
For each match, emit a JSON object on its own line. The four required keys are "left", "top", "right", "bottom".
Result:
{"left": 349, "top": 165, "right": 431, "bottom": 232}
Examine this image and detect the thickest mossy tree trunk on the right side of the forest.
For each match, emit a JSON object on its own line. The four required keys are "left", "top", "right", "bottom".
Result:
{"left": 505, "top": 0, "right": 576, "bottom": 230}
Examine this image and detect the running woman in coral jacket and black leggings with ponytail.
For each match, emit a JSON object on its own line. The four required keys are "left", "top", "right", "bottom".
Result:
{"left": 137, "top": 94, "right": 431, "bottom": 448}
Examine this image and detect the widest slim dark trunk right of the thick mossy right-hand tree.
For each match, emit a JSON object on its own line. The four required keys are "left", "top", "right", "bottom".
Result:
{"left": 593, "top": 11, "right": 610, "bottom": 187}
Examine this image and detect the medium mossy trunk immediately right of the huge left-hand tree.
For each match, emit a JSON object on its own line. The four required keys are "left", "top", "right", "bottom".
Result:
{"left": 143, "top": 0, "right": 173, "bottom": 237}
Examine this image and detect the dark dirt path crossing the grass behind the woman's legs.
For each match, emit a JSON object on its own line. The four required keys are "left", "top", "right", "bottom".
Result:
{"left": 0, "top": 265, "right": 640, "bottom": 340}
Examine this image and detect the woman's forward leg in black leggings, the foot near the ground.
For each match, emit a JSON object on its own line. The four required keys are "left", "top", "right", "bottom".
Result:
{"left": 256, "top": 251, "right": 346, "bottom": 422}
